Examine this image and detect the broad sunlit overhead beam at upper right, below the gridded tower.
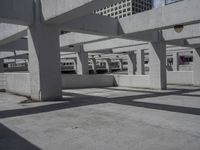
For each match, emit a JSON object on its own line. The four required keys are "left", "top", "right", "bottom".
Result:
{"left": 119, "top": 0, "right": 200, "bottom": 34}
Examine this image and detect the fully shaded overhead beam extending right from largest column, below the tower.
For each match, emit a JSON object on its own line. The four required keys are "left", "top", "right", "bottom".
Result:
{"left": 60, "top": 14, "right": 120, "bottom": 36}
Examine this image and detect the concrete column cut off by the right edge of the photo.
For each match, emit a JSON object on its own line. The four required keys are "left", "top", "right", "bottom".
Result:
{"left": 193, "top": 48, "right": 200, "bottom": 86}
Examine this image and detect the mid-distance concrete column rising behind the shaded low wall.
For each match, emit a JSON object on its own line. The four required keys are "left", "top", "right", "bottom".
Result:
{"left": 75, "top": 46, "right": 89, "bottom": 75}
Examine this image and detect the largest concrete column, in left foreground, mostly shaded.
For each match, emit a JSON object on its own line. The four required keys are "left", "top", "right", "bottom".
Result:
{"left": 28, "top": 1, "right": 62, "bottom": 101}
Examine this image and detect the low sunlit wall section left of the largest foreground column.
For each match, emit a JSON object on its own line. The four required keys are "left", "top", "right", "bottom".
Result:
{"left": 1, "top": 73, "right": 30, "bottom": 96}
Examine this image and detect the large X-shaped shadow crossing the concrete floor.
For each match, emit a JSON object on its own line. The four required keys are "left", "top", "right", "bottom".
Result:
{"left": 0, "top": 89, "right": 200, "bottom": 118}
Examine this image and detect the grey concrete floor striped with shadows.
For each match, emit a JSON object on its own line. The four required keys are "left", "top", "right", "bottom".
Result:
{"left": 0, "top": 86, "right": 200, "bottom": 150}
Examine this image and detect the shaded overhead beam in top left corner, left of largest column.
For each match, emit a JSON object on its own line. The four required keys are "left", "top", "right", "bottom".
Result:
{"left": 0, "top": 0, "right": 34, "bottom": 25}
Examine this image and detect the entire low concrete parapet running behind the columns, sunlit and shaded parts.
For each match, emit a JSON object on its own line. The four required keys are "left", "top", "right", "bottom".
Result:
{"left": 0, "top": 71, "right": 193, "bottom": 96}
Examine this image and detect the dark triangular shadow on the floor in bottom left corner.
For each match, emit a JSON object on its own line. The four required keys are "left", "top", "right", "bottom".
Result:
{"left": 0, "top": 123, "right": 41, "bottom": 150}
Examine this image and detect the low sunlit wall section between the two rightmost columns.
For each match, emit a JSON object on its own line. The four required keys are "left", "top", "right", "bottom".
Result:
{"left": 167, "top": 71, "right": 193, "bottom": 85}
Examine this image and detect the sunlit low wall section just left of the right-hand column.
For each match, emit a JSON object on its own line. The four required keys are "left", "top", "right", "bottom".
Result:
{"left": 114, "top": 75, "right": 150, "bottom": 88}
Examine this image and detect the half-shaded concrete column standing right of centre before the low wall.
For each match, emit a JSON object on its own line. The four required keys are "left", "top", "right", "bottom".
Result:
{"left": 149, "top": 42, "right": 167, "bottom": 90}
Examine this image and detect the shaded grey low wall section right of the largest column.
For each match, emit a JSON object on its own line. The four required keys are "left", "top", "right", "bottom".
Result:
{"left": 62, "top": 75, "right": 114, "bottom": 89}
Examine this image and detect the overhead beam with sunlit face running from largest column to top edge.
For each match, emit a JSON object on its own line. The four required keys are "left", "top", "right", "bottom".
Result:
{"left": 41, "top": 0, "right": 122, "bottom": 24}
